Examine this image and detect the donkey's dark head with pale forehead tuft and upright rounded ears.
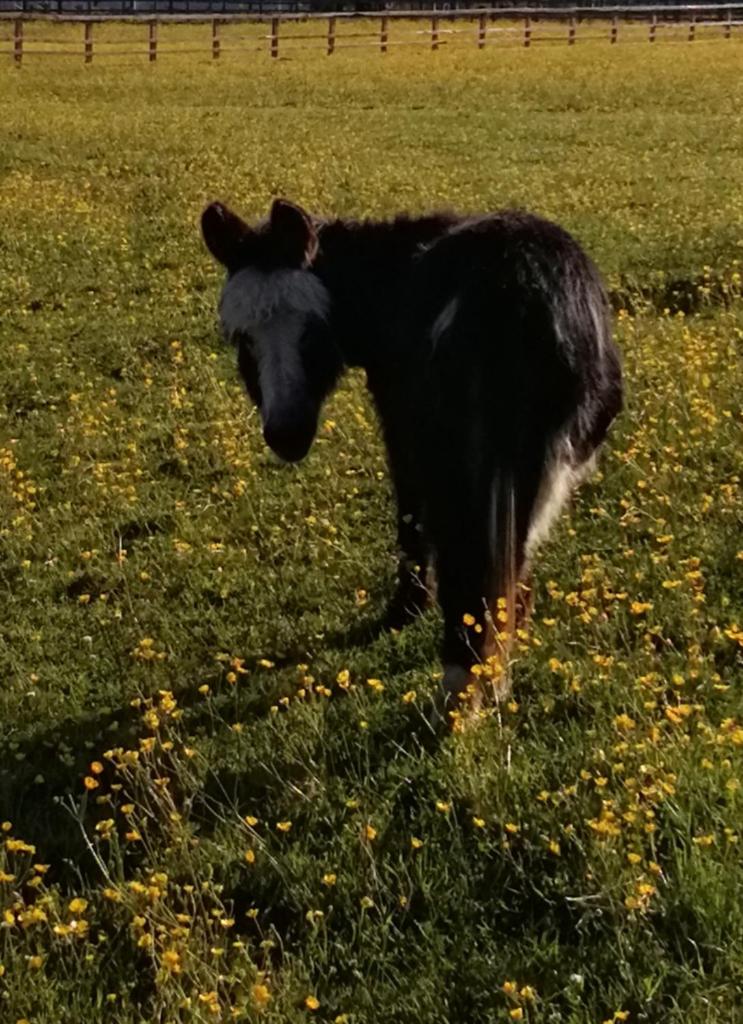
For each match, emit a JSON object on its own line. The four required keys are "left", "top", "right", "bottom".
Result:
{"left": 202, "top": 199, "right": 343, "bottom": 462}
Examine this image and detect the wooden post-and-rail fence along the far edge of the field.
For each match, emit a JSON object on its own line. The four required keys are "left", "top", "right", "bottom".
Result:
{"left": 0, "top": 3, "right": 743, "bottom": 67}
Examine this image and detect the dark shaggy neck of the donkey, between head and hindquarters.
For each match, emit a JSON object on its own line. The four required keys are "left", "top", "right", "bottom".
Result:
{"left": 314, "top": 213, "right": 458, "bottom": 372}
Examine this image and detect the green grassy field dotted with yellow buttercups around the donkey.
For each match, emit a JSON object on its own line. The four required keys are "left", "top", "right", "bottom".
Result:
{"left": 0, "top": 40, "right": 743, "bottom": 1024}
